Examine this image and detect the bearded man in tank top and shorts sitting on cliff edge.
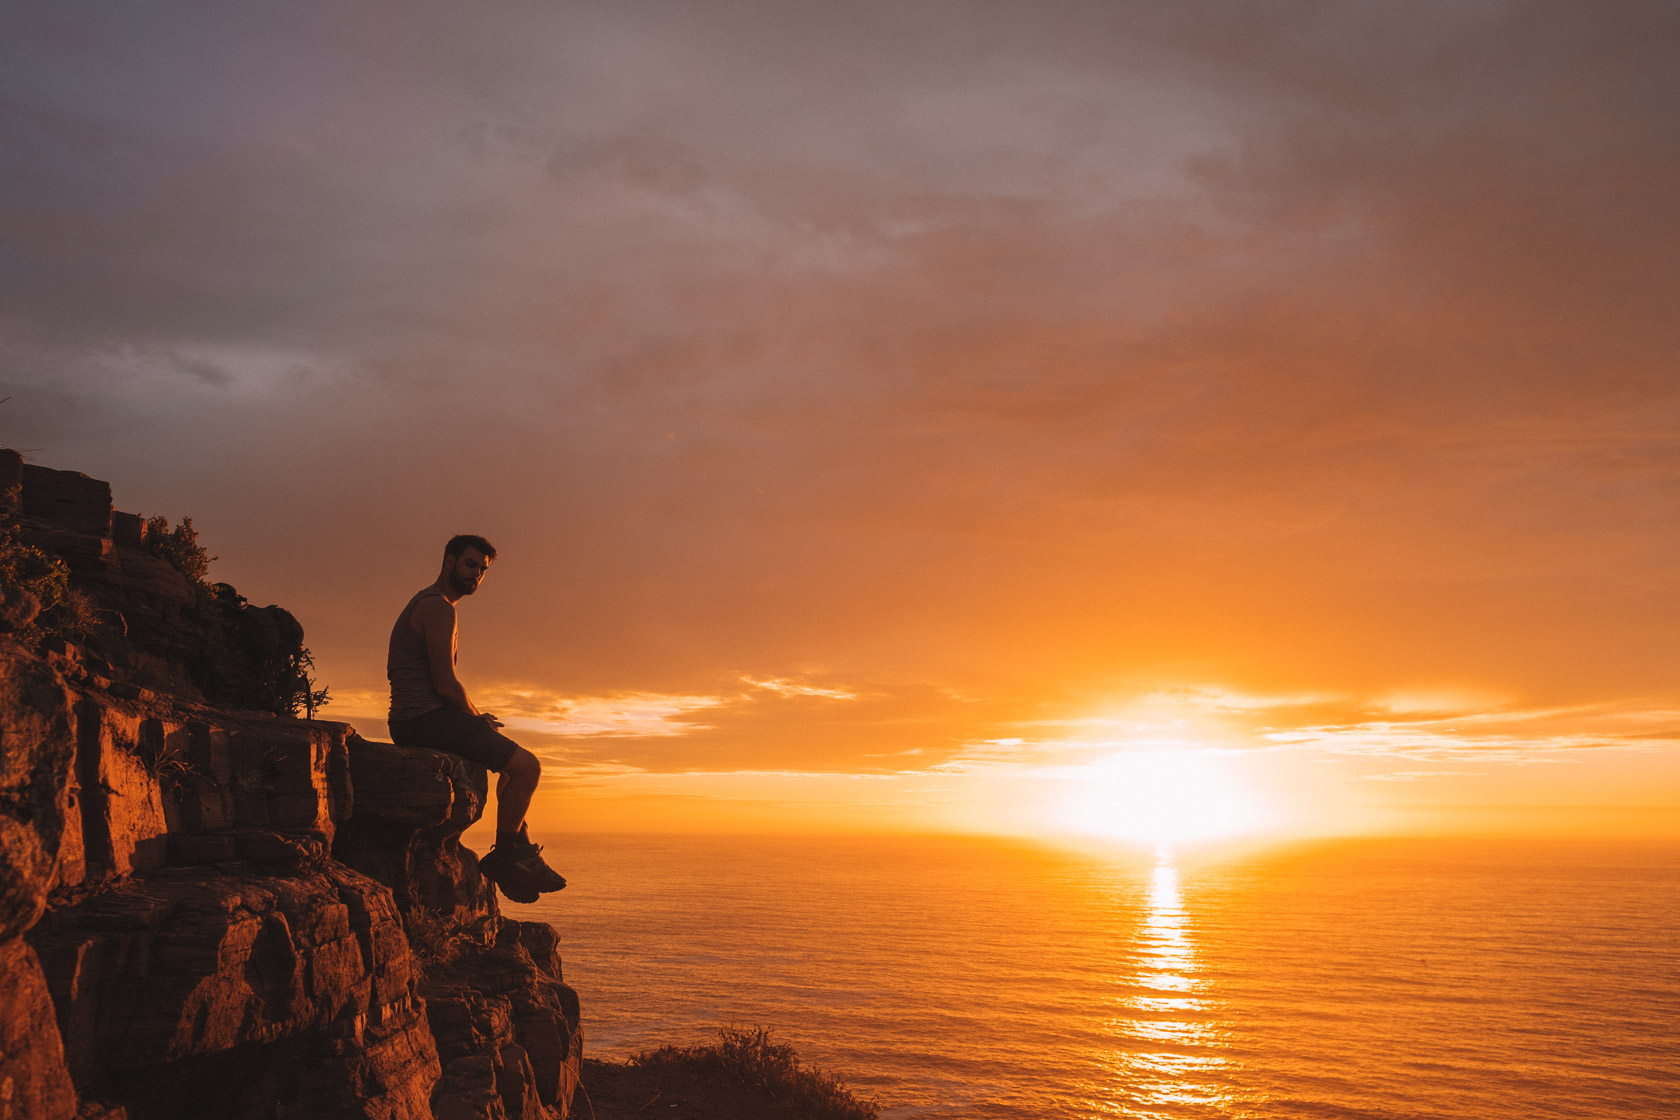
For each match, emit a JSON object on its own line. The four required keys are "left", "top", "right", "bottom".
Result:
{"left": 385, "top": 534, "right": 566, "bottom": 902}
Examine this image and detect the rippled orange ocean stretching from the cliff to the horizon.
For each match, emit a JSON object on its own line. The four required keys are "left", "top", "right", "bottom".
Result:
{"left": 506, "top": 835, "right": 1680, "bottom": 1120}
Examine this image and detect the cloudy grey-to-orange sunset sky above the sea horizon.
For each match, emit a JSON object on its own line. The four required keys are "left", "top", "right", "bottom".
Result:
{"left": 0, "top": 0, "right": 1680, "bottom": 840}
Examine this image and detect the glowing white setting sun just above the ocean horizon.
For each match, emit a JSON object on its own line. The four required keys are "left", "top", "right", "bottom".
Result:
{"left": 1058, "top": 751, "right": 1270, "bottom": 845}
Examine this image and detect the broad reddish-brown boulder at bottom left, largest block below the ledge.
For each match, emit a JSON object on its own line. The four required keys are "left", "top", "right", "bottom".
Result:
{"left": 30, "top": 860, "right": 438, "bottom": 1120}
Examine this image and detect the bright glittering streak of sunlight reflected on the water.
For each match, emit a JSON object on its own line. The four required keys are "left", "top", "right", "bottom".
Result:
{"left": 1105, "top": 851, "right": 1236, "bottom": 1118}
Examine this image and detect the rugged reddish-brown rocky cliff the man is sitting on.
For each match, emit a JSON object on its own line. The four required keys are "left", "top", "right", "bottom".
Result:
{"left": 0, "top": 450, "right": 581, "bottom": 1120}
